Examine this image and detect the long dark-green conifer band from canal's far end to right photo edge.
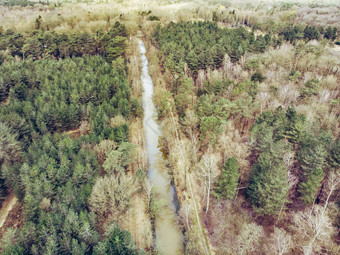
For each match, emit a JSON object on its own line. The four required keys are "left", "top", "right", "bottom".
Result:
{"left": 154, "top": 21, "right": 337, "bottom": 74}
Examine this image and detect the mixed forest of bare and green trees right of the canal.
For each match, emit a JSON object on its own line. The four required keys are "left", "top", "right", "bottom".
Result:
{"left": 151, "top": 16, "right": 340, "bottom": 254}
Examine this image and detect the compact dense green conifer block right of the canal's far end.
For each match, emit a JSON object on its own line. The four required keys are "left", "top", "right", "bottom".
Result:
{"left": 154, "top": 22, "right": 271, "bottom": 73}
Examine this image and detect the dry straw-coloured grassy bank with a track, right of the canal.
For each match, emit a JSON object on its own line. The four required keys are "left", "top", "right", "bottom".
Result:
{"left": 145, "top": 37, "right": 214, "bottom": 254}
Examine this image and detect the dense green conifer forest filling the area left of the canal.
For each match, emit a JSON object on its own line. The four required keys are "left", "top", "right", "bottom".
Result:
{"left": 0, "top": 23, "right": 142, "bottom": 254}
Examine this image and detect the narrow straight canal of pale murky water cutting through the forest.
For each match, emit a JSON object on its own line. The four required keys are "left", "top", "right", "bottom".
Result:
{"left": 139, "top": 40, "right": 183, "bottom": 255}
